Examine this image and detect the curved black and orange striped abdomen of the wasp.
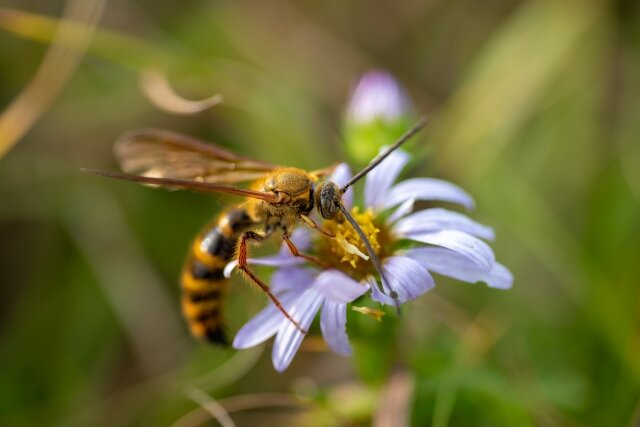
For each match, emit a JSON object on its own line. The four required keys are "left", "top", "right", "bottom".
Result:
{"left": 181, "top": 208, "right": 253, "bottom": 344}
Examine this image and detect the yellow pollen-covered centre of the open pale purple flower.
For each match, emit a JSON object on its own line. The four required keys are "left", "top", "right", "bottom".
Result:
{"left": 322, "top": 207, "right": 381, "bottom": 273}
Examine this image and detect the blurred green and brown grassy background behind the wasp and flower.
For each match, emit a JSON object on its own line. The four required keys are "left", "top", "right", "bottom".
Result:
{"left": 0, "top": 0, "right": 640, "bottom": 427}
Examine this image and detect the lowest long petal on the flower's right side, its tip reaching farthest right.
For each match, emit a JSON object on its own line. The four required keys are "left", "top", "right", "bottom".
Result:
{"left": 406, "top": 247, "right": 513, "bottom": 289}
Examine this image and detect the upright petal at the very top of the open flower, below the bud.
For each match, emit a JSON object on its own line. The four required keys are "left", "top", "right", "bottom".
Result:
{"left": 364, "top": 148, "right": 409, "bottom": 209}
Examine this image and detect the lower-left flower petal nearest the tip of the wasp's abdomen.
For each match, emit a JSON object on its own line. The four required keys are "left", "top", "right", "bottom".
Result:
{"left": 233, "top": 291, "right": 302, "bottom": 350}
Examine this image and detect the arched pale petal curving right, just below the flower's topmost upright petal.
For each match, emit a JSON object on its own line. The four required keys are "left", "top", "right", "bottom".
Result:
{"left": 382, "top": 178, "right": 474, "bottom": 209}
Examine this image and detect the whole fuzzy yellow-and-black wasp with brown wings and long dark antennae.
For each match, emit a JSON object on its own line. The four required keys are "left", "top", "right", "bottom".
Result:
{"left": 83, "top": 118, "right": 426, "bottom": 344}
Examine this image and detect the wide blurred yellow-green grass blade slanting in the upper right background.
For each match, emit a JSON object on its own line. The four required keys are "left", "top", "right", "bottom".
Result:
{"left": 430, "top": 1, "right": 606, "bottom": 177}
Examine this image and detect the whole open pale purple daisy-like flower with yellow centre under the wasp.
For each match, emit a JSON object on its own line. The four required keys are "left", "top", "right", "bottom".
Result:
{"left": 230, "top": 151, "right": 513, "bottom": 371}
